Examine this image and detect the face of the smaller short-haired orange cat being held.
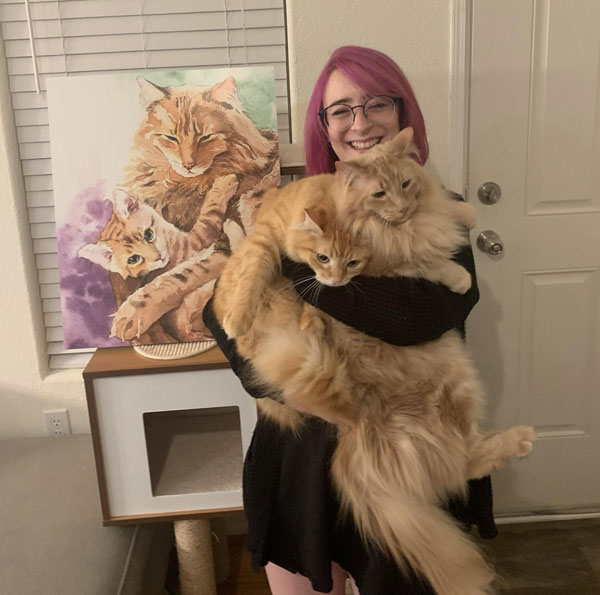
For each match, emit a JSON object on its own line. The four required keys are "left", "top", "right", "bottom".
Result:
{"left": 295, "top": 209, "right": 371, "bottom": 287}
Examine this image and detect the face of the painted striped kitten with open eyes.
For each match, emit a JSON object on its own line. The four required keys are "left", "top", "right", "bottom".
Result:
{"left": 78, "top": 191, "right": 169, "bottom": 279}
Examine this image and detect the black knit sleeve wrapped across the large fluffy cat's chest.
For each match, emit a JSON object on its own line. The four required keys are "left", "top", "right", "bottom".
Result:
{"left": 282, "top": 241, "right": 479, "bottom": 345}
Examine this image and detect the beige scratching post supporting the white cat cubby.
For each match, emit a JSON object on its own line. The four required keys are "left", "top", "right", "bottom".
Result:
{"left": 174, "top": 519, "right": 217, "bottom": 595}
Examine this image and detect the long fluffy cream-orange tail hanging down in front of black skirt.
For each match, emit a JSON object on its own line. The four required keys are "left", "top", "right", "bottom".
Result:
{"left": 332, "top": 424, "right": 494, "bottom": 595}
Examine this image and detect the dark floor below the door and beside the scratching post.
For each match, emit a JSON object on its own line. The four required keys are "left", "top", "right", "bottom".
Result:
{"left": 218, "top": 519, "right": 600, "bottom": 595}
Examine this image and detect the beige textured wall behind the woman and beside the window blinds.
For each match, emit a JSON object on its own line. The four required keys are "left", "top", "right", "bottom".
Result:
{"left": 0, "top": 0, "right": 452, "bottom": 438}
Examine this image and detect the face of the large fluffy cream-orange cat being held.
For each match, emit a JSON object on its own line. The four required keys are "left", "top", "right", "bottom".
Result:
{"left": 336, "top": 129, "right": 424, "bottom": 225}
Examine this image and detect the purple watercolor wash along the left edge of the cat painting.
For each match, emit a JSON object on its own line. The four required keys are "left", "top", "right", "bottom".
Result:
{"left": 56, "top": 181, "right": 126, "bottom": 349}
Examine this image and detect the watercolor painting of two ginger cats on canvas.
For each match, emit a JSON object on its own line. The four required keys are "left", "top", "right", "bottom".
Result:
{"left": 48, "top": 66, "right": 280, "bottom": 349}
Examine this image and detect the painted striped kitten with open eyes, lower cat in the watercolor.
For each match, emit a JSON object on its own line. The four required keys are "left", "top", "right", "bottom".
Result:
{"left": 78, "top": 174, "right": 241, "bottom": 343}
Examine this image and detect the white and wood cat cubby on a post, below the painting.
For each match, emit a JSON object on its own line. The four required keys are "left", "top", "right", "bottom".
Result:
{"left": 83, "top": 347, "right": 256, "bottom": 595}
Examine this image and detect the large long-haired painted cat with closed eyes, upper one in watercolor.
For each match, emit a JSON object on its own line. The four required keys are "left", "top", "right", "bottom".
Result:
{"left": 110, "top": 77, "right": 280, "bottom": 343}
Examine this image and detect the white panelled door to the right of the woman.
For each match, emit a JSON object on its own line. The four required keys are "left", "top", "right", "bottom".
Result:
{"left": 467, "top": 0, "right": 600, "bottom": 513}
